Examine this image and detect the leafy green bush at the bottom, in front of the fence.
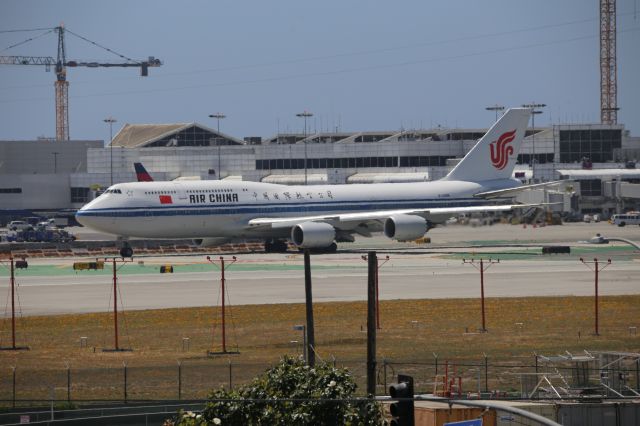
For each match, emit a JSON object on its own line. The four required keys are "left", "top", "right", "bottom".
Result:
{"left": 185, "top": 357, "right": 385, "bottom": 426}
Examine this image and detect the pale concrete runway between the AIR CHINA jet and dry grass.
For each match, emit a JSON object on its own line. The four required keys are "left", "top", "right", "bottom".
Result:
{"left": 0, "top": 226, "right": 640, "bottom": 315}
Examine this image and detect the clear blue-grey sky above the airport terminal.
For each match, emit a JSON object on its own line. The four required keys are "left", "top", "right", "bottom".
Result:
{"left": 0, "top": 0, "right": 640, "bottom": 140}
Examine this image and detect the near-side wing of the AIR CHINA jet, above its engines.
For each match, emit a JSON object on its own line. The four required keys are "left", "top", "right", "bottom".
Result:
{"left": 247, "top": 204, "right": 542, "bottom": 229}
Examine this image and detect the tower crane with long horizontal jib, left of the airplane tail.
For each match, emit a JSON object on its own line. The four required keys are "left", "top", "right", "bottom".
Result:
{"left": 0, "top": 25, "right": 162, "bottom": 141}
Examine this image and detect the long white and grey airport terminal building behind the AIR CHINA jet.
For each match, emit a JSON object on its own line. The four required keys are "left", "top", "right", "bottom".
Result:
{"left": 0, "top": 119, "right": 640, "bottom": 220}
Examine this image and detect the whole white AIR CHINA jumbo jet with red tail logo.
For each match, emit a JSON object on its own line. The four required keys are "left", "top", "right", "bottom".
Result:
{"left": 76, "top": 108, "right": 548, "bottom": 257}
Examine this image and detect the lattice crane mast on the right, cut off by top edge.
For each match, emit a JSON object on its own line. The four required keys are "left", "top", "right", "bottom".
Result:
{"left": 600, "top": 0, "right": 618, "bottom": 124}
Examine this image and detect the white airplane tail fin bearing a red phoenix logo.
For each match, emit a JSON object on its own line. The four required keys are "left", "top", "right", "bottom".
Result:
{"left": 444, "top": 108, "right": 531, "bottom": 182}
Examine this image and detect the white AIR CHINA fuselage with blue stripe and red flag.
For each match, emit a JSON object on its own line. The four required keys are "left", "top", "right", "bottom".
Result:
{"left": 76, "top": 179, "right": 519, "bottom": 238}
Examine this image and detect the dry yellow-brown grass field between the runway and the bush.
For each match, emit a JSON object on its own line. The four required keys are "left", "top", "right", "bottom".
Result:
{"left": 0, "top": 296, "right": 640, "bottom": 400}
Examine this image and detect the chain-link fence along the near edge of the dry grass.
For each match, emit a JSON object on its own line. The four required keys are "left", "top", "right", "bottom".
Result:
{"left": 0, "top": 356, "right": 640, "bottom": 406}
